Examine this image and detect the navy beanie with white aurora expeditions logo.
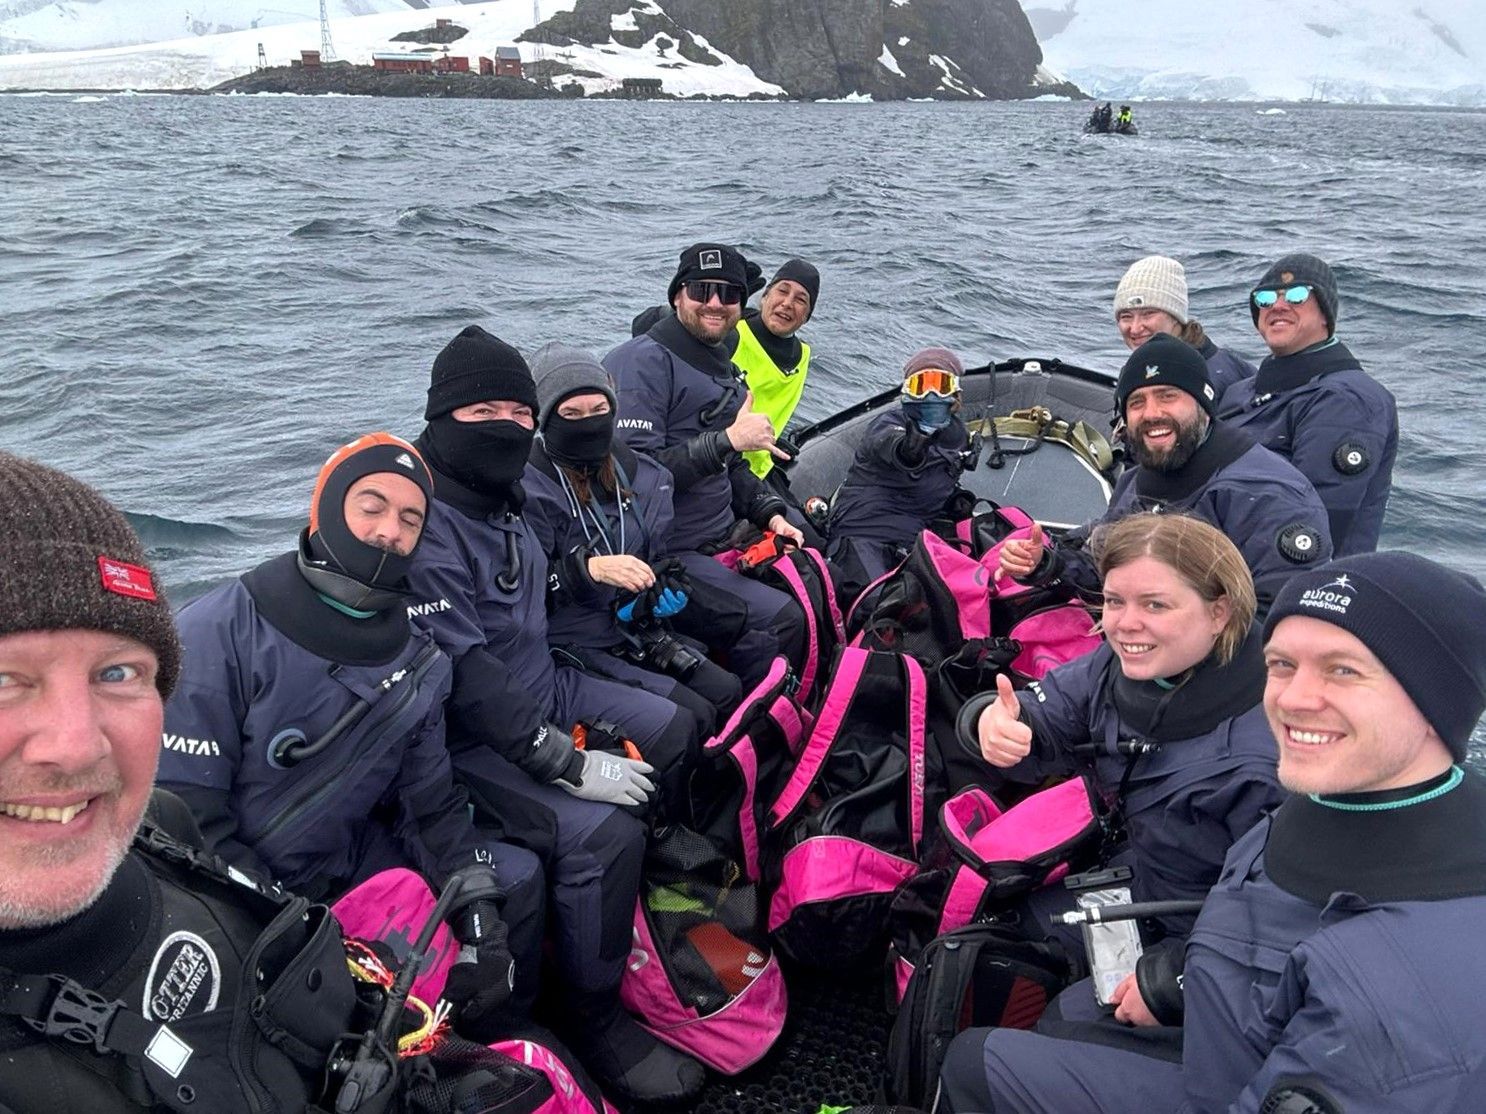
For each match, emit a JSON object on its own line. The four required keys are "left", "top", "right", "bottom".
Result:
{"left": 1265, "top": 550, "right": 1486, "bottom": 762}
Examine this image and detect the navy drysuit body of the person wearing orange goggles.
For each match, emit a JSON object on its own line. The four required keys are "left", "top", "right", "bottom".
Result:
{"left": 828, "top": 407, "right": 970, "bottom": 600}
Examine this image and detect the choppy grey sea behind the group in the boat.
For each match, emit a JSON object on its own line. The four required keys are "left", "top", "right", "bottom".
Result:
{"left": 0, "top": 95, "right": 1486, "bottom": 745}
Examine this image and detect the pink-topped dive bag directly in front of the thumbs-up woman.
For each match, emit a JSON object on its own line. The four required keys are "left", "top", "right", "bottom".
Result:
{"left": 889, "top": 777, "right": 1101, "bottom": 1000}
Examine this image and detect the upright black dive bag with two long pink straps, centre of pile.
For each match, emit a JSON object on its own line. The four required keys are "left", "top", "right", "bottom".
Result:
{"left": 765, "top": 648, "right": 927, "bottom": 968}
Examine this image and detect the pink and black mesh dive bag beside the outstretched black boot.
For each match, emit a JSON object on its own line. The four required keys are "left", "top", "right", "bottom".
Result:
{"left": 620, "top": 826, "right": 788, "bottom": 1075}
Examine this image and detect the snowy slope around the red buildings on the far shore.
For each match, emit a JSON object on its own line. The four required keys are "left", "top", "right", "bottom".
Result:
{"left": 0, "top": 0, "right": 783, "bottom": 97}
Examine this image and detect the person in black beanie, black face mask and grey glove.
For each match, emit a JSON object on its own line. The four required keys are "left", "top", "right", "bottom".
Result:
{"left": 409, "top": 325, "right": 703, "bottom": 1102}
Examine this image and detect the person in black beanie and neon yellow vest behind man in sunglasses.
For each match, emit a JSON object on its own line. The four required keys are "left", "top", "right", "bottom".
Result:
{"left": 733, "top": 258, "right": 820, "bottom": 478}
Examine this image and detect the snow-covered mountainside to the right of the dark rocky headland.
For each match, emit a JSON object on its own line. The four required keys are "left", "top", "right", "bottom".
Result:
{"left": 1021, "top": 0, "right": 1486, "bottom": 105}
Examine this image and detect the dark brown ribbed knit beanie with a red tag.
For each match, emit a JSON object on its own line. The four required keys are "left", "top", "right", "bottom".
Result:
{"left": 0, "top": 453, "right": 181, "bottom": 697}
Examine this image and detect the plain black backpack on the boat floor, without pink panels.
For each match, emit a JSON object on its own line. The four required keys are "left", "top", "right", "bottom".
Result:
{"left": 884, "top": 919, "right": 1068, "bottom": 1110}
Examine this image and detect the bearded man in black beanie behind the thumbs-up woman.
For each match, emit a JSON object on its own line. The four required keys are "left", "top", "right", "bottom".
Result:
{"left": 999, "top": 333, "right": 1331, "bottom": 615}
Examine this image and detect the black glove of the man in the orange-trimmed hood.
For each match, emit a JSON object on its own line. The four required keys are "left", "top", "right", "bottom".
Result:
{"left": 444, "top": 866, "right": 516, "bottom": 1044}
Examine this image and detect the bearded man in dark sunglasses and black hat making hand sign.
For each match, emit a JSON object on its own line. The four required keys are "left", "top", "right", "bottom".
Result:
{"left": 603, "top": 244, "right": 805, "bottom": 688}
